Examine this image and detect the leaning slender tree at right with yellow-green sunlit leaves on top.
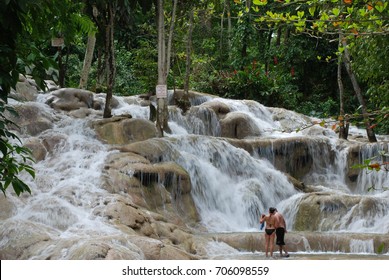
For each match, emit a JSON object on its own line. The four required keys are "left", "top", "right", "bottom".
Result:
{"left": 249, "top": 0, "right": 389, "bottom": 142}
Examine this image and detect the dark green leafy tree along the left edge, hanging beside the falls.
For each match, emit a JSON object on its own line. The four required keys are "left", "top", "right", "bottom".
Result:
{"left": 0, "top": 0, "right": 93, "bottom": 195}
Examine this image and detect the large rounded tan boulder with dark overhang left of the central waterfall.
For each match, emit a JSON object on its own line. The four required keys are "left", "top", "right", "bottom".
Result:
{"left": 103, "top": 149, "right": 199, "bottom": 224}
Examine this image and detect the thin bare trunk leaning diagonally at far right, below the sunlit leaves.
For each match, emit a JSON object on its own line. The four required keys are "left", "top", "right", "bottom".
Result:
{"left": 341, "top": 38, "right": 377, "bottom": 142}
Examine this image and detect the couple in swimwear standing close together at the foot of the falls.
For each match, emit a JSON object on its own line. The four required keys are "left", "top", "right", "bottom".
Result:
{"left": 259, "top": 207, "right": 289, "bottom": 258}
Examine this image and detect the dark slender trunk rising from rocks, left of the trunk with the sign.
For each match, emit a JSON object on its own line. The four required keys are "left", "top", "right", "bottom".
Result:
{"left": 103, "top": 1, "right": 116, "bottom": 118}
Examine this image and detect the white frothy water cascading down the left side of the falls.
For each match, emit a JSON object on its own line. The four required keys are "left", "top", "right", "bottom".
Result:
{"left": 8, "top": 99, "right": 118, "bottom": 236}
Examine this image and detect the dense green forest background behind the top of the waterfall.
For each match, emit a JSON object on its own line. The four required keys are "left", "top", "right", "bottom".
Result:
{"left": 2, "top": 0, "right": 389, "bottom": 131}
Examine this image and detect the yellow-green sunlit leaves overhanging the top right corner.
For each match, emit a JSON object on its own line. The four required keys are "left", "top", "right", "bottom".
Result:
{"left": 253, "top": 0, "right": 389, "bottom": 36}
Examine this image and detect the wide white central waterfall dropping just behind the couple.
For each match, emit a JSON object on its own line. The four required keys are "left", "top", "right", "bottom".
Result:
{"left": 161, "top": 136, "right": 297, "bottom": 232}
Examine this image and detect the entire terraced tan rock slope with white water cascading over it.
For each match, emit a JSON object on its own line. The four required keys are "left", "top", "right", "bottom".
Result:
{"left": 0, "top": 80, "right": 389, "bottom": 259}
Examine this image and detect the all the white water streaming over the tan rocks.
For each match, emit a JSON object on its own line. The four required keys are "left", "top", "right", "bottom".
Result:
{"left": 2, "top": 89, "right": 389, "bottom": 258}
